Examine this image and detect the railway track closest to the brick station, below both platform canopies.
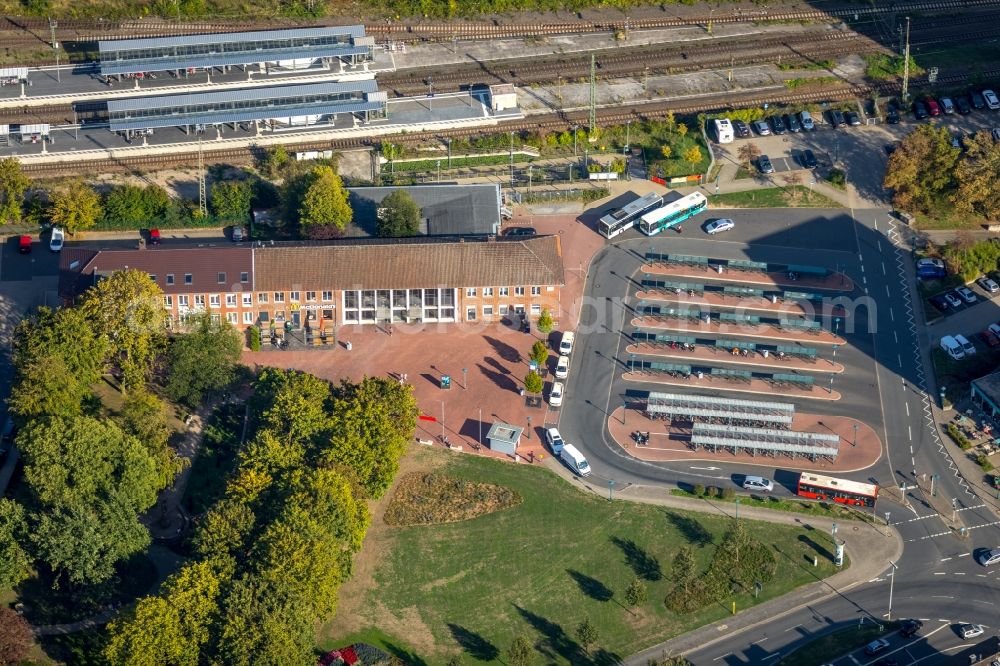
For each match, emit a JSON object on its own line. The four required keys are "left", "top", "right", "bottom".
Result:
{"left": 23, "top": 64, "right": 1000, "bottom": 178}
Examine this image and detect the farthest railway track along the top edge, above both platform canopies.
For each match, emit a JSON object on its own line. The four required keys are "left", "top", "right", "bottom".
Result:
{"left": 0, "top": 0, "right": 1000, "bottom": 42}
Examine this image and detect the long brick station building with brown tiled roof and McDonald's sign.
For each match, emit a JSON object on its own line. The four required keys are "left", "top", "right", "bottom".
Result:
{"left": 59, "top": 236, "right": 564, "bottom": 331}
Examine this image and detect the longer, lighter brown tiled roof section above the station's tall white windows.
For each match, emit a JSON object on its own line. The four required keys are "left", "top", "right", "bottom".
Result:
{"left": 254, "top": 236, "right": 564, "bottom": 291}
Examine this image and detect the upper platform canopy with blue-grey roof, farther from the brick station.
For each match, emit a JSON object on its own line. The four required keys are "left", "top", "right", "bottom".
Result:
{"left": 98, "top": 25, "right": 375, "bottom": 76}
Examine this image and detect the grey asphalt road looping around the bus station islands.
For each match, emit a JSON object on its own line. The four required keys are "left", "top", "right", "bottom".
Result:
{"left": 559, "top": 210, "right": 1000, "bottom": 666}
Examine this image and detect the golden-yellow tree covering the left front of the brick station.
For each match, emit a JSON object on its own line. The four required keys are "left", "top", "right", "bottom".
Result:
{"left": 82, "top": 269, "right": 166, "bottom": 390}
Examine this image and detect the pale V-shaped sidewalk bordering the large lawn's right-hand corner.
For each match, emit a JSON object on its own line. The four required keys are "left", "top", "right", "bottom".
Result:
{"left": 545, "top": 460, "right": 903, "bottom": 666}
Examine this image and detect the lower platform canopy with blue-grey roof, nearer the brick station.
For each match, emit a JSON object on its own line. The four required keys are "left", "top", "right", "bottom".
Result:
{"left": 108, "top": 79, "right": 387, "bottom": 132}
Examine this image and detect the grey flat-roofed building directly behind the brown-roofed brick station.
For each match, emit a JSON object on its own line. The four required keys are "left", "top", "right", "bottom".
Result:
{"left": 347, "top": 183, "right": 502, "bottom": 236}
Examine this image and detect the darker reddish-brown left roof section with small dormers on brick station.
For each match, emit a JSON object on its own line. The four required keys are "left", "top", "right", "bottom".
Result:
{"left": 59, "top": 245, "right": 254, "bottom": 298}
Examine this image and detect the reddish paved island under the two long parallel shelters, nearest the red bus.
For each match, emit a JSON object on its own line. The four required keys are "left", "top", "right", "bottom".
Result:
{"left": 608, "top": 407, "right": 882, "bottom": 473}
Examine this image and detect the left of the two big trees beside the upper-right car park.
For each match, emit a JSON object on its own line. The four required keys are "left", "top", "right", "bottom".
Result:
{"left": 883, "top": 125, "right": 961, "bottom": 213}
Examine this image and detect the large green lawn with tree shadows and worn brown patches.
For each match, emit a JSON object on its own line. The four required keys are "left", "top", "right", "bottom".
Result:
{"left": 320, "top": 449, "right": 848, "bottom": 664}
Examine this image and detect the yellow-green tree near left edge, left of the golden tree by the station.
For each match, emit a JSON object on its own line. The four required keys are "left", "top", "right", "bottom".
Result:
{"left": 9, "top": 308, "right": 108, "bottom": 418}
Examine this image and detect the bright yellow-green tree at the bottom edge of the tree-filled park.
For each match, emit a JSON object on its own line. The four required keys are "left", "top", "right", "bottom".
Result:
{"left": 104, "top": 562, "right": 221, "bottom": 666}
